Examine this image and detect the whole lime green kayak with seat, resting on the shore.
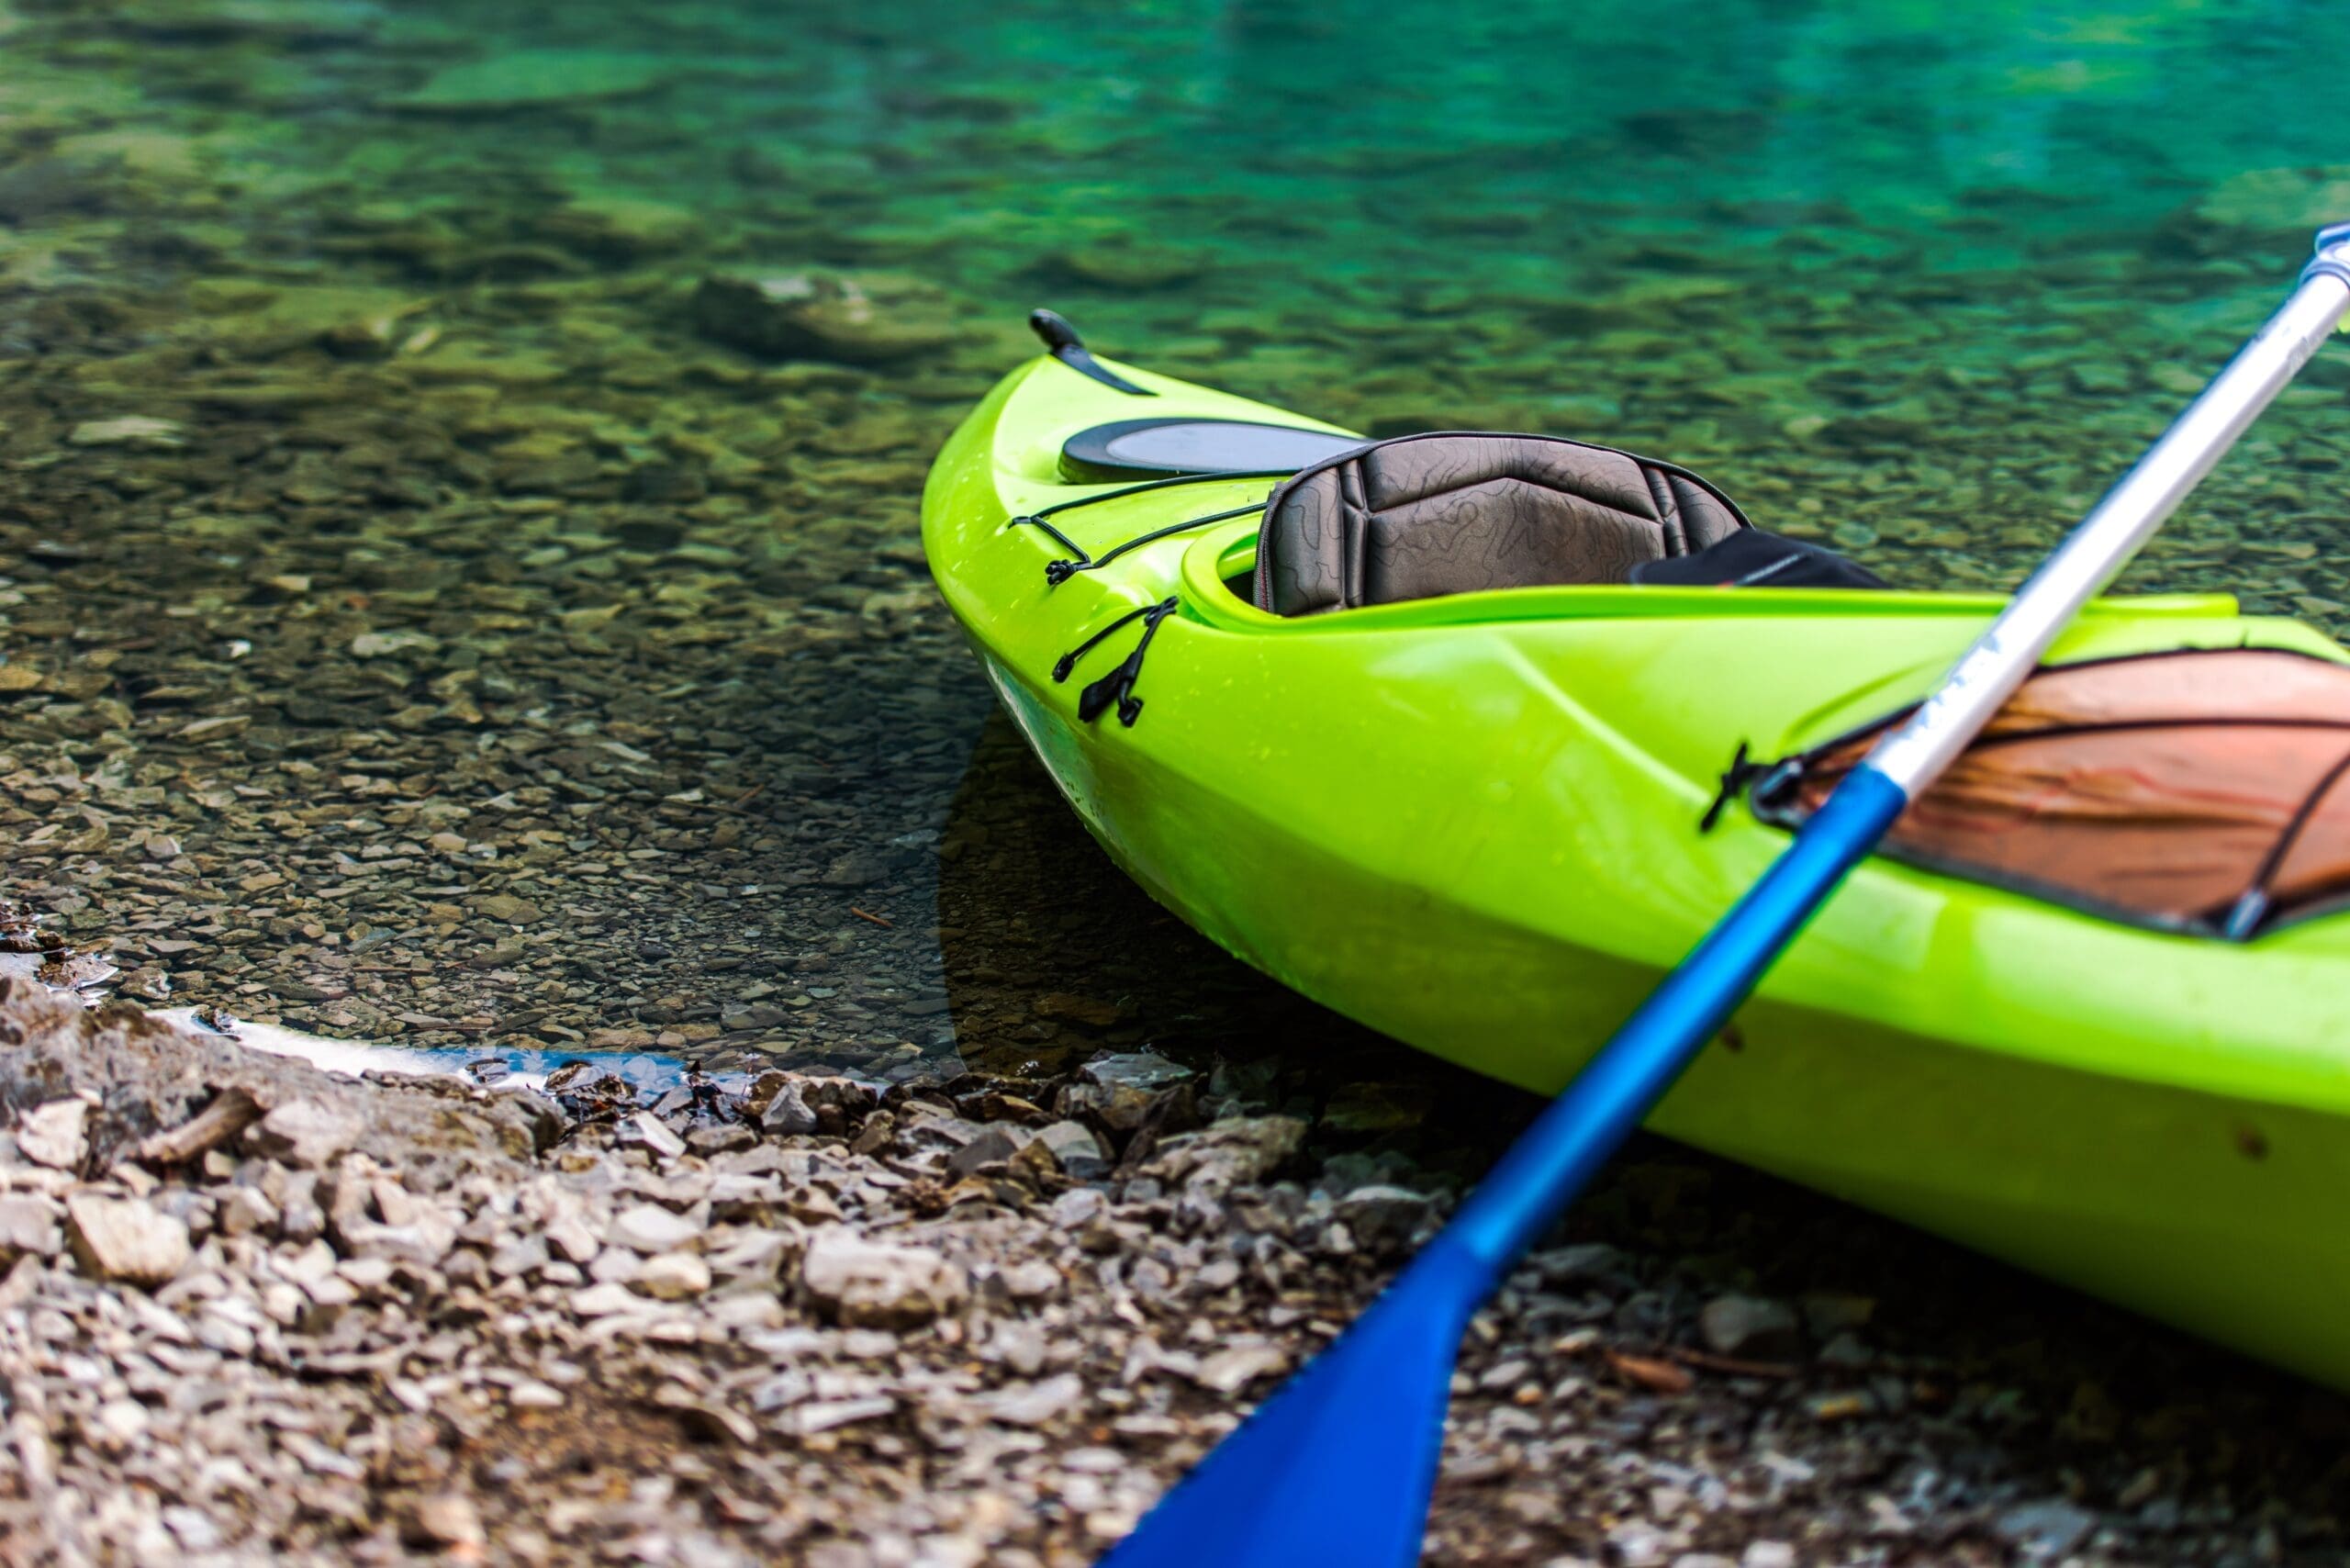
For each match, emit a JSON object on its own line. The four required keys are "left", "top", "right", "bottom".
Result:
{"left": 923, "top": 318, "right": 2350, "bottom": 1387}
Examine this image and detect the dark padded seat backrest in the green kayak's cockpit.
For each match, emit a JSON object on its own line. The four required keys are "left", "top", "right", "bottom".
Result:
{"left": 1255, "top": 432, "right": 1749, "bottom": 616}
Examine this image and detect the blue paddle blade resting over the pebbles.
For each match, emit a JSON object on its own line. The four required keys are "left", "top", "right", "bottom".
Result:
{"left": 1102, "top": 1241, "right": 1490, "bottom": 1568}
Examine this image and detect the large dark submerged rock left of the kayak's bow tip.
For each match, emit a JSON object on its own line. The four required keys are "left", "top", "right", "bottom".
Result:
{"left": 693, "top": 270, "right": 957, "bottom": 364}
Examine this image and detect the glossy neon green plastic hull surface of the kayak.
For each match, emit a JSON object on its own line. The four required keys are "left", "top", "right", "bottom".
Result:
{"left": 923, "top": 360, "right": 2350, "bottom": 1387}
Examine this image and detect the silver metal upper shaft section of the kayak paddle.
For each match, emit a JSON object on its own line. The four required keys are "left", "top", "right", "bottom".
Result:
{"left": 1868, "top": 235, "right": 2350, "bottom": 800}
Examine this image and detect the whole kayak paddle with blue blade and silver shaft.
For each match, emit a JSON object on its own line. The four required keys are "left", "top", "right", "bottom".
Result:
{"left": 1104, "top": 223, "right": 2350, "bottom": 1568}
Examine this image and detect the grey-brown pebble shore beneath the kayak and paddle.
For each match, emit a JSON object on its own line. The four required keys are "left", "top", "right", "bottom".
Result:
{"left": 0, "top": 978, "right": 2350, "bottom": 1568}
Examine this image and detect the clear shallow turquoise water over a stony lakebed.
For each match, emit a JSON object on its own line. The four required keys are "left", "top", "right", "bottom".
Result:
{"left": 0, "top": 0, "right": 2350, "bottom": 1077}
